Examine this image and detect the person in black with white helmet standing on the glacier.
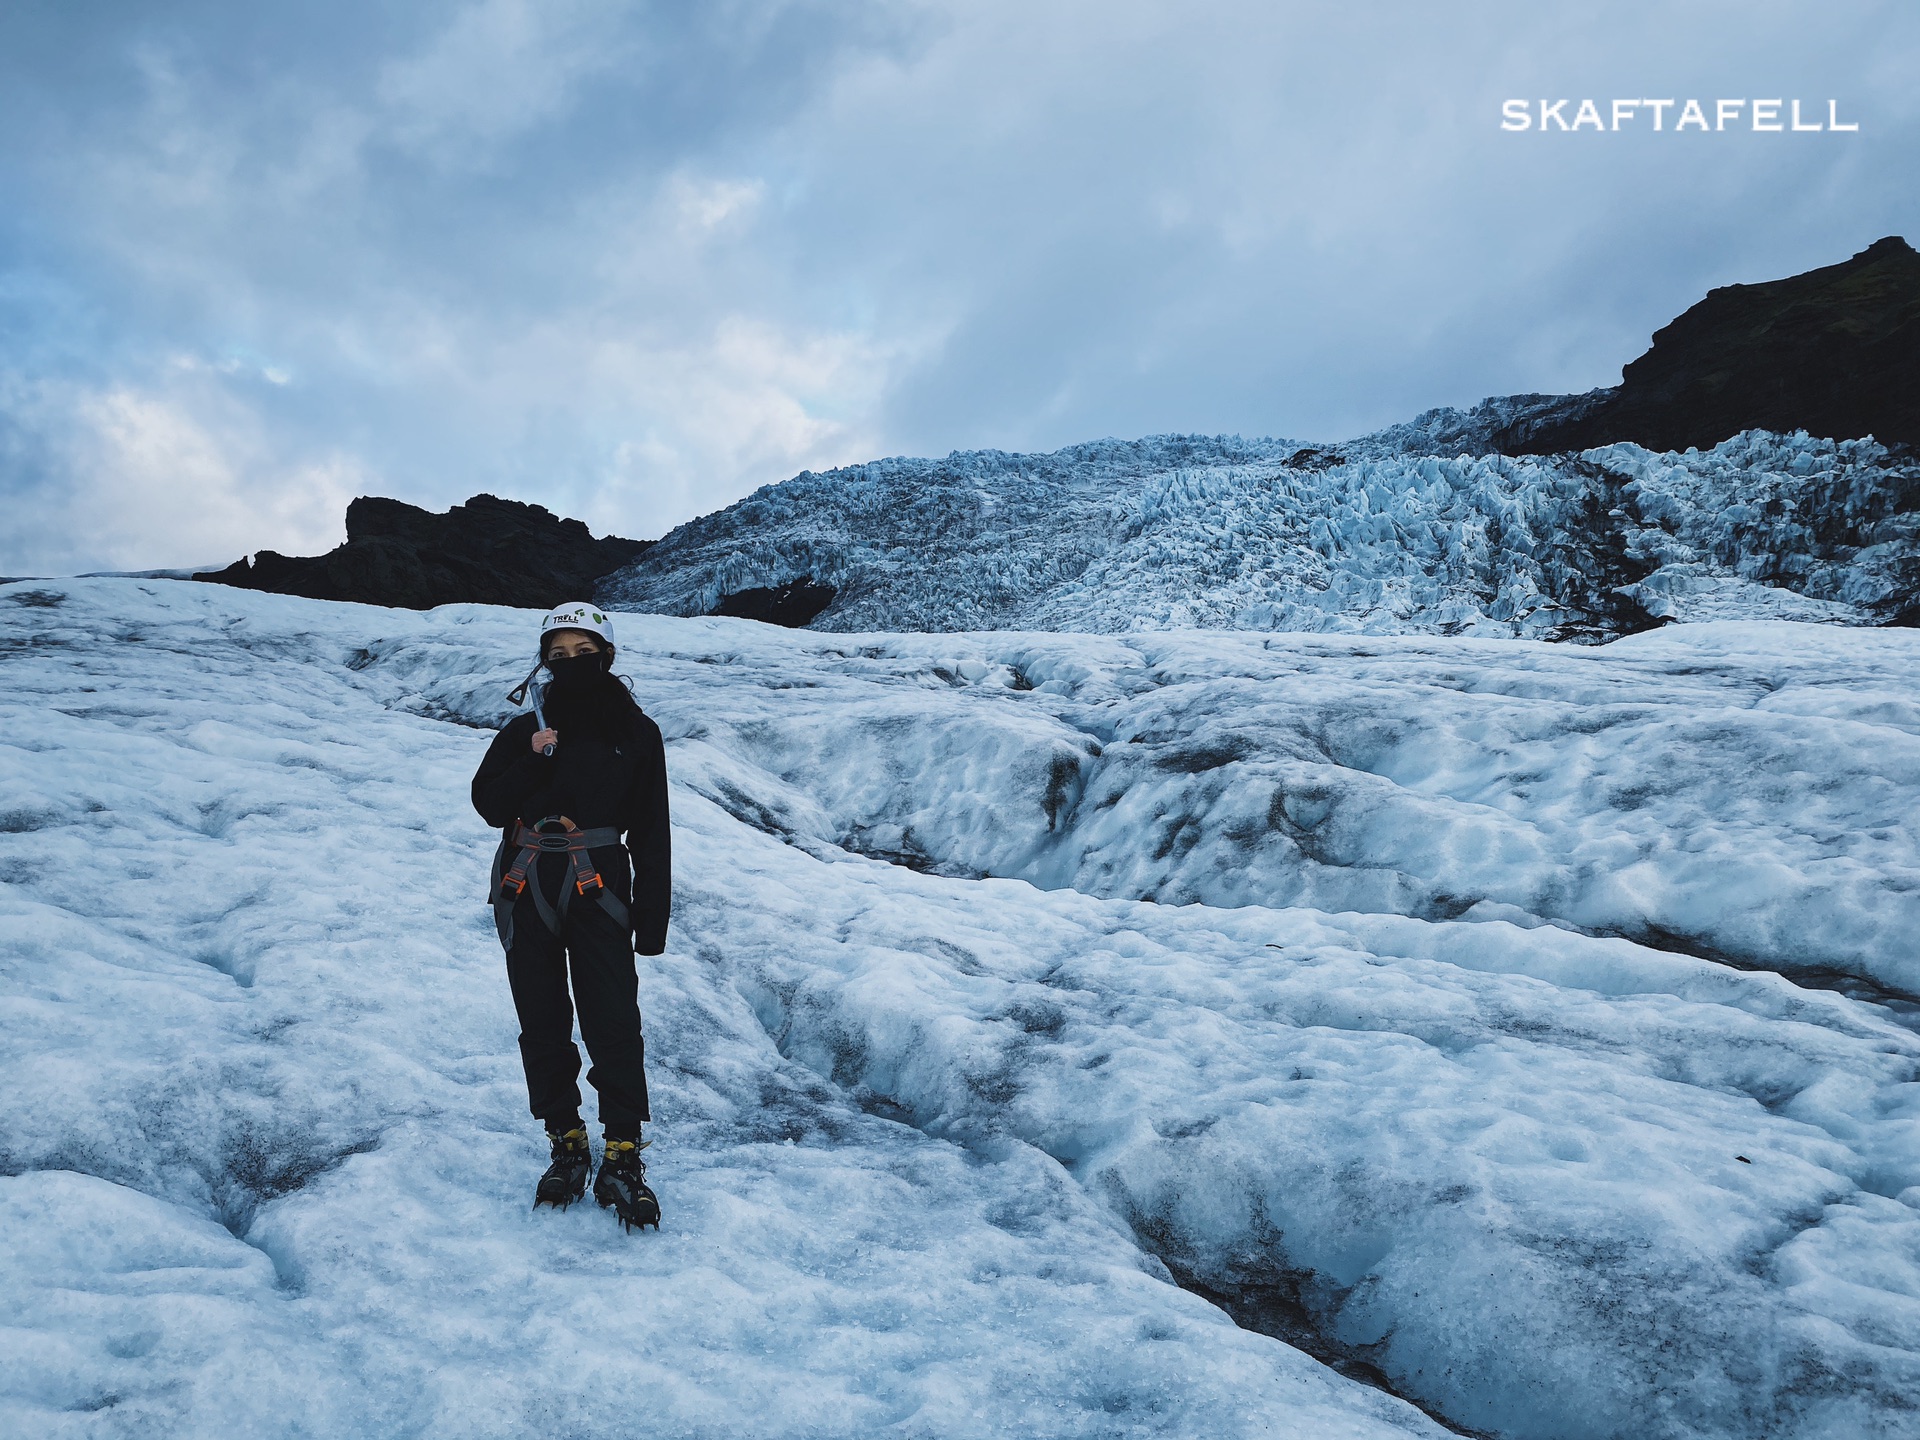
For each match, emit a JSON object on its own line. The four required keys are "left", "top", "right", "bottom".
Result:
{"left": 472, "top": 603, "right": 672, "bottom": 1229}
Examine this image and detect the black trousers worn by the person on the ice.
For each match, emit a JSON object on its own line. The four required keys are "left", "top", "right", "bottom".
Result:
{"left": 507, "top": 879, "right": 653, "bottom": 1140}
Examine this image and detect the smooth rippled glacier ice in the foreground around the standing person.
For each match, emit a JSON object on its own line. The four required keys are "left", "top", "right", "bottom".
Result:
{"left": 0, "top": 580, "right": 1920, "bottom": 1440}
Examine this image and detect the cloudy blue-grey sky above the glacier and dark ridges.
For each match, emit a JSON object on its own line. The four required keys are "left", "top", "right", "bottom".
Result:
{"left": 0, "top": 0, "right": 1920, "bottom": 574}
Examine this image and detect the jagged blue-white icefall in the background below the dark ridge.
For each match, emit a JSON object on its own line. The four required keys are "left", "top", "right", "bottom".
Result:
{"left": 601, "top": 420, "right": 1920, "bottom": 639}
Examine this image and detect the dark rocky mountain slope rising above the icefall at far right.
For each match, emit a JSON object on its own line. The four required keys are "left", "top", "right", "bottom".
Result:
{"left": 1494, "top": 236, "right": 1920, "bottom": 455}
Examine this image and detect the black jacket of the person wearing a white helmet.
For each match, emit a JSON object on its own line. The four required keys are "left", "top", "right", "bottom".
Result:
{"left": 474, "top": 710, "right": 674, "bottom": 954}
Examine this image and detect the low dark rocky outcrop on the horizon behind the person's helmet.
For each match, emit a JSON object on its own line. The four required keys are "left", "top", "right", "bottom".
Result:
{"left": 194, "top": 495, "right": 653, "bottom": 611}
